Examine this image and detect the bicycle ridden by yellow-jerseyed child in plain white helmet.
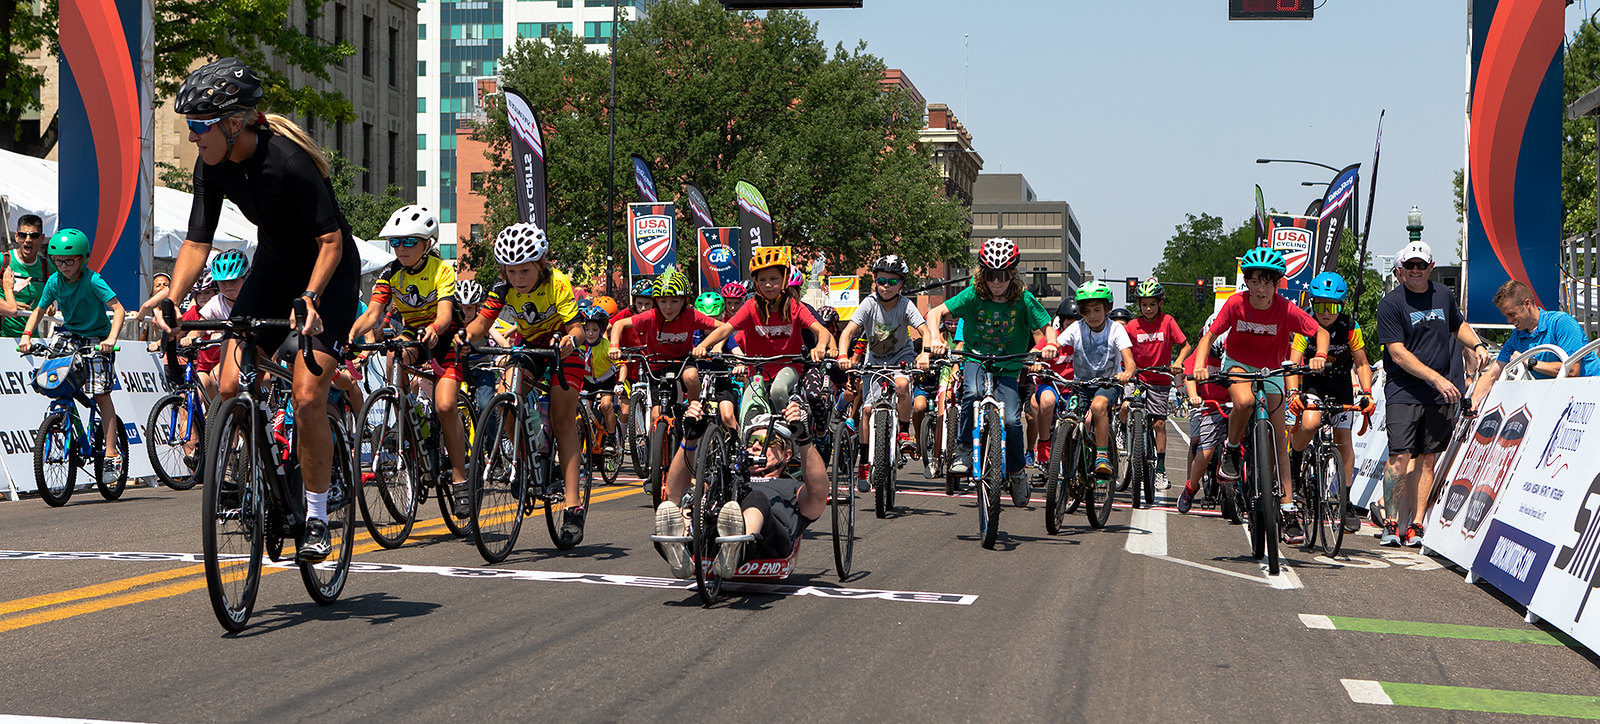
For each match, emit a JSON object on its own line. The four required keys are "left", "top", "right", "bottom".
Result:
{"left": 349, "top": 336, "right": 472, "bottom": 548}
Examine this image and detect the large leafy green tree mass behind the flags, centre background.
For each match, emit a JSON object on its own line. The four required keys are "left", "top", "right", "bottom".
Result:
{"left": 464, "top": 0, "right": 970, "bottom": 288}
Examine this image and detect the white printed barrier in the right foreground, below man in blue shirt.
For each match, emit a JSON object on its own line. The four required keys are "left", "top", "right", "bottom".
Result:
{"left": 1422, "top": 341, "right": 1600, "bottom": 652}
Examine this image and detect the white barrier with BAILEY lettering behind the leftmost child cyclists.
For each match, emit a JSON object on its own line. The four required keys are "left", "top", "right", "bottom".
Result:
{"left": 0, "top": 347, "right": 166, "bottom": 500}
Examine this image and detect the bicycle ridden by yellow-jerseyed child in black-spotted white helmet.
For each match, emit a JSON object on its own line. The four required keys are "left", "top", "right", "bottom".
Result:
{"left": 467, "top": 344, "right": 594, "bottom": 564}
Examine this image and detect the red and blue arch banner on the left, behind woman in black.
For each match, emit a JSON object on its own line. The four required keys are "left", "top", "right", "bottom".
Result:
{"left": 59, "top": 0, "right": 146, "bottom": 306}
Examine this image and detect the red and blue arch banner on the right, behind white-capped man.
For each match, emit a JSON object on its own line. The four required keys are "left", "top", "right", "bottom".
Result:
{"left": 1472, "top": 0, "right": 1566, "bottom": 324}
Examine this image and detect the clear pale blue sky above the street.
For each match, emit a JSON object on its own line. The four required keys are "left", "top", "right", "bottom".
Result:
{"left": 806, "top": 0, "right": 1600, "bottom": 279}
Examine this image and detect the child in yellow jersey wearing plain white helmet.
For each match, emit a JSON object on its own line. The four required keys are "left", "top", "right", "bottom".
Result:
{"left": 350, "top": 205, "right": 470, "bottom": 517}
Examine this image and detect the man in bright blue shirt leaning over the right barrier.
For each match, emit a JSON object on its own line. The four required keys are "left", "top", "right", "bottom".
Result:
{"left": 1472, "top": 279, "right": 1600, "bottom": 408}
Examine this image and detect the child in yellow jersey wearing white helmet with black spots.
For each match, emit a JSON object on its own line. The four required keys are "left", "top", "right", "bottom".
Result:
{"left": 467, "top": 223, "right": 587, "bottom": 549}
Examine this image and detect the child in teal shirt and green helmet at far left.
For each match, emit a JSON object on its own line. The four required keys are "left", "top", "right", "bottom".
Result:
{"left": 18, "top": 229, "right": 123, "bottom": 484}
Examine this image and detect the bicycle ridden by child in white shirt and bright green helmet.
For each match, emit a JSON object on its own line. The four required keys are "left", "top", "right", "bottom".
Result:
{"left": 1038, "top": 370, "right": 1122, "bottom": 535}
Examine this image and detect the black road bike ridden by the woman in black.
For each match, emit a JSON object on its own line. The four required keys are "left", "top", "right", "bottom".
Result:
{"left": 176, "top": 298, "right": 360, "bottom": 631}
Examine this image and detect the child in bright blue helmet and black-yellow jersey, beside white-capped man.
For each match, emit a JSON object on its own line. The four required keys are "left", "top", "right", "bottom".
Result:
{"left": 1288, "top": 272, "right": 1376, "bottom": 533}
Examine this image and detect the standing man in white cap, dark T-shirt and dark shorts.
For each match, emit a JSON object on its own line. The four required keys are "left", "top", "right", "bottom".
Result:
{"left": 1378, "top": 242, "right": 1486, "bottom": 546}
